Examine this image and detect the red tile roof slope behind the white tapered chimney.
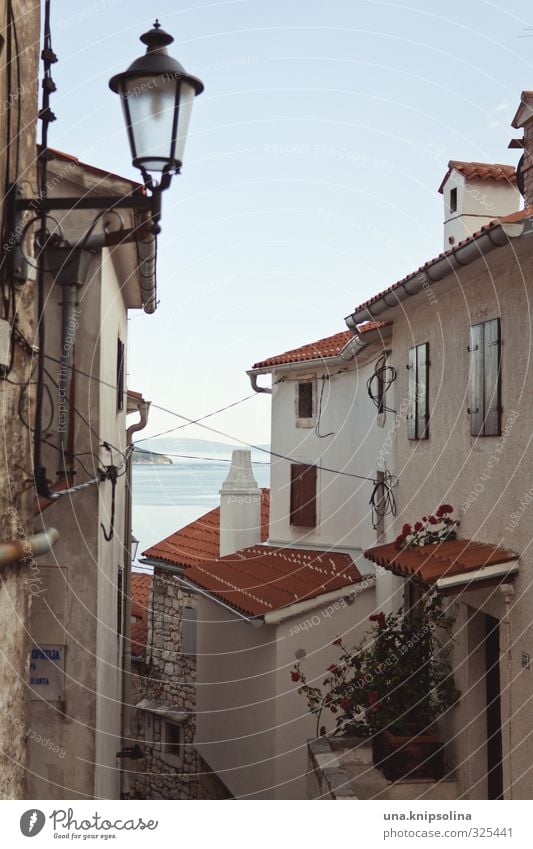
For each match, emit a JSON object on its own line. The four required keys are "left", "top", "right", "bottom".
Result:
{"left": 143, "top": 489, "right": 270, "bottom": 567}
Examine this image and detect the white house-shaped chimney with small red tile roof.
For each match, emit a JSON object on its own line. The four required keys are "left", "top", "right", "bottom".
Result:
{"left": 439, "top": 159, "right": 520, "bottom": 251}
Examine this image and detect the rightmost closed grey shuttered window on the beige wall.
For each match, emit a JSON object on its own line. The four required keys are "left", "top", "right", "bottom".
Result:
{"left": 468, "top": 318, "right": 501, "bottom": 436}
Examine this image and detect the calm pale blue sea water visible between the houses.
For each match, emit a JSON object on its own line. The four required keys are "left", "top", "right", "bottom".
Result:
{"left": 133, "top": 461, "right": 270, "bottom": 556}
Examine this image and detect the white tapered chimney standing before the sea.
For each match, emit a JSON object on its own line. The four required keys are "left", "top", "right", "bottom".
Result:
{"left": 220, "top": 448, "right": 261, "bottom": 557}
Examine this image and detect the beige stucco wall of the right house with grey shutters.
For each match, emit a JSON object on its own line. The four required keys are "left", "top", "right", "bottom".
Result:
{"left": 393, "top": 241, "right": 533, "bottom": 798}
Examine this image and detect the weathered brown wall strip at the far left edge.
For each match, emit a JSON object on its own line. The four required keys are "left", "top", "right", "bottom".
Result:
{"left": 0, "top": 0, "right": 39, "bottom": 799}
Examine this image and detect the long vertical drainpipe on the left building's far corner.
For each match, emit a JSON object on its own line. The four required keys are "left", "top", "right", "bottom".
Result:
{"left": 121, "top": 395, "right": 150, "bottom": 796}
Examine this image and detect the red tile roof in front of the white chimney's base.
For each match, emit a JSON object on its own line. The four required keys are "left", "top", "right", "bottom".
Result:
{"left": 184, "top": 545, "right": 362, "bottom": 616}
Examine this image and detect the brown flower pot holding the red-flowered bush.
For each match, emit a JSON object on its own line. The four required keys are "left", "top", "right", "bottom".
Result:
{"left": 374, "top": 730, "right": 444, "bottom": 781}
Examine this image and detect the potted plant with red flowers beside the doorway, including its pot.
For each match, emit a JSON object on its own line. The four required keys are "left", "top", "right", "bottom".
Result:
{"left": 291, "top": 593, "right": 459, "bottom": 780}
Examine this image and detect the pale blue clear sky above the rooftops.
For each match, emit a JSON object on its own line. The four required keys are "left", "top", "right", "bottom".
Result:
{"left": 49, "top": 0, "right": 533, "bottom": 443}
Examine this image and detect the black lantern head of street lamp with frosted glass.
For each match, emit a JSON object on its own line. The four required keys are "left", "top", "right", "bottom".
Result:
{"left": 109, "top": 20, "right": 204, "bottom": 189}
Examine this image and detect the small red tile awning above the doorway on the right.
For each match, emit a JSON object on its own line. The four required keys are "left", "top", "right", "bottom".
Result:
{"left": 365, "top": 539, "right": 518, "bottom": 584}
